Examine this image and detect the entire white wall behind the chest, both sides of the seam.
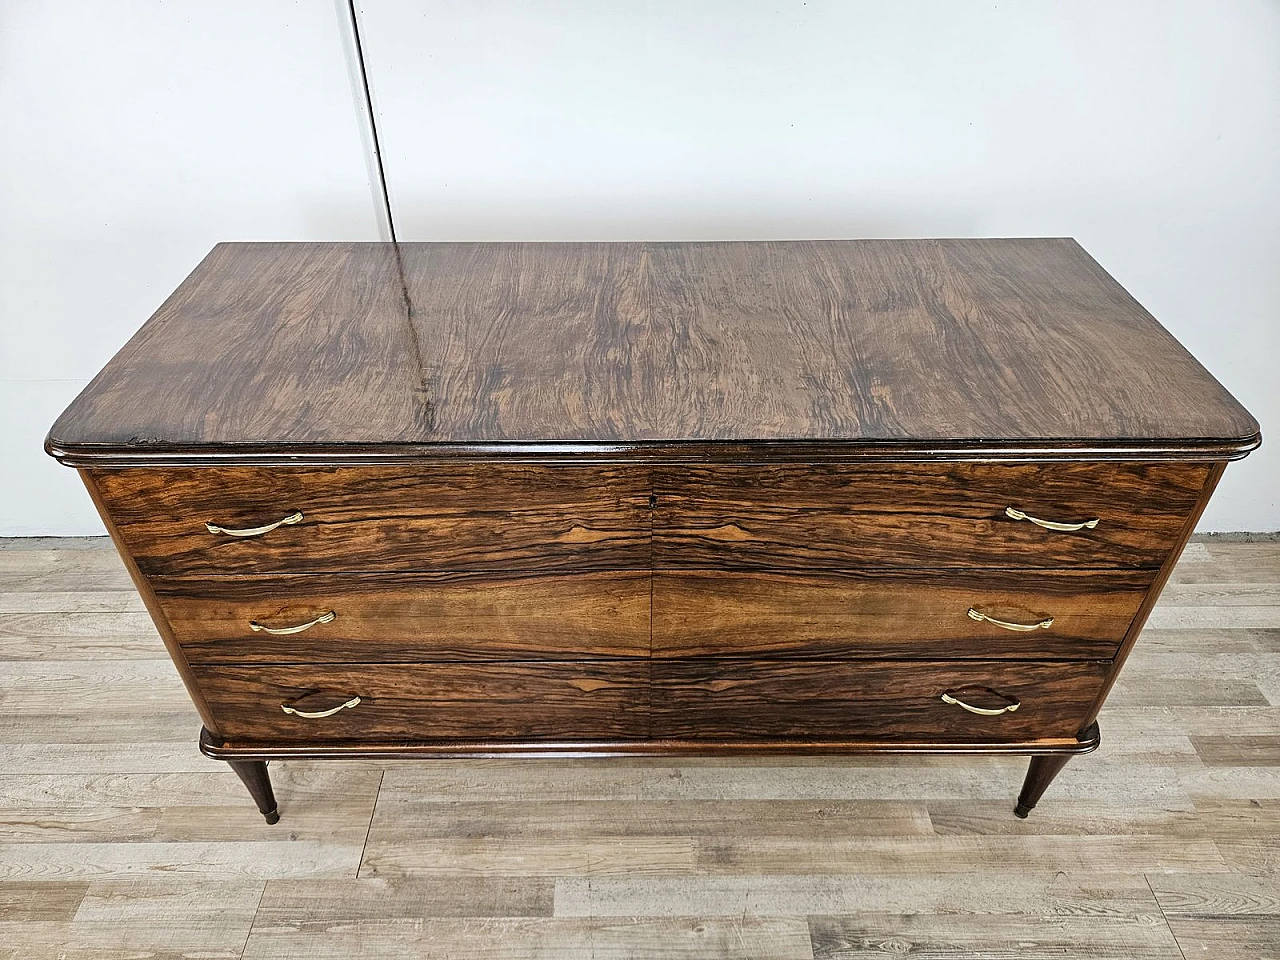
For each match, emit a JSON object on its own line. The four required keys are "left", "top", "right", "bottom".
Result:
{"left": 0, "top": 0, "right": 1280, "bottom": 535}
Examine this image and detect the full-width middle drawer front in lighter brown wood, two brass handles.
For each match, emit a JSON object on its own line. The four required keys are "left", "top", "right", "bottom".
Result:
{"left": 151, "top": 570, "right": 1149, "bottom": 663}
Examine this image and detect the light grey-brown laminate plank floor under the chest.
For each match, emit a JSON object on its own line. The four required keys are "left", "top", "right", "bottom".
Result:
{"left": 0, "top": 540, "right": 1280, "bottom": 960}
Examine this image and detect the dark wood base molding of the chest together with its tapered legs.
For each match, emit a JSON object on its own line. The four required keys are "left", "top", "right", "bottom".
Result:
{"left": 200, "top": 722, "right": 1102, "bottom": 823}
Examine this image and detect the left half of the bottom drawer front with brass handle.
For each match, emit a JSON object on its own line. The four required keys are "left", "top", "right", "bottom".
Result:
{"left": 192, "top": 660, "right": 649, "bottom": 742}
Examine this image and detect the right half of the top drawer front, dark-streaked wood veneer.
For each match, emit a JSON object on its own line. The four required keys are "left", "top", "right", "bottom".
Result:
{"left": 654, "top": 462, "right": 1210, "bottom": 568}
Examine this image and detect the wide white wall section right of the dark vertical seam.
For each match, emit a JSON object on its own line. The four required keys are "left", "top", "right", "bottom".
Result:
{"left": 361, "top": 0, "right": 1280, "bottom": 530}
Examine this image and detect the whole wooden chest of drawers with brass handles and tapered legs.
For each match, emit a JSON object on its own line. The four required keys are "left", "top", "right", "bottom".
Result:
{"left": 46, "top": 239, "right": 1260, "bottom": 822}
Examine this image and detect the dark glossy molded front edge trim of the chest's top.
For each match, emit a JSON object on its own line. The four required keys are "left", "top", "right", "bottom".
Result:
{"left": 45, "top": 433, "right": 1262, "bottom": 468}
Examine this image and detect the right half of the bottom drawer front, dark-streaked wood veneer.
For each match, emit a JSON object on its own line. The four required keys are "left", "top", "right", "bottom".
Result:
{"left": 653, "top": 659, "right": 1110, "bottom": 744}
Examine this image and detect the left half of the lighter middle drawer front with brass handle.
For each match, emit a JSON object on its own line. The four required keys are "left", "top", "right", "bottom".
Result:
{"left": 151, "top": 572, "right": 650, "bottom": 663}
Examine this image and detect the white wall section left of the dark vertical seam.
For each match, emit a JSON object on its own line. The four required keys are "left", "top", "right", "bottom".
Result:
{"left": 0, "top": 0, "right": 378, "bottom": 535}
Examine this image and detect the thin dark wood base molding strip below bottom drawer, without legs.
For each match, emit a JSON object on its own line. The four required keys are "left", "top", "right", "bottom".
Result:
{"left": 200, "top": 723, "right": 1101, "bottom": 760}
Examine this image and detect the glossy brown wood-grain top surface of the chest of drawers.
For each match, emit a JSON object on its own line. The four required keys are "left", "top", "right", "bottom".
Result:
{"left": 47, "top": 239, "right": 1258, "bottom": 461}
